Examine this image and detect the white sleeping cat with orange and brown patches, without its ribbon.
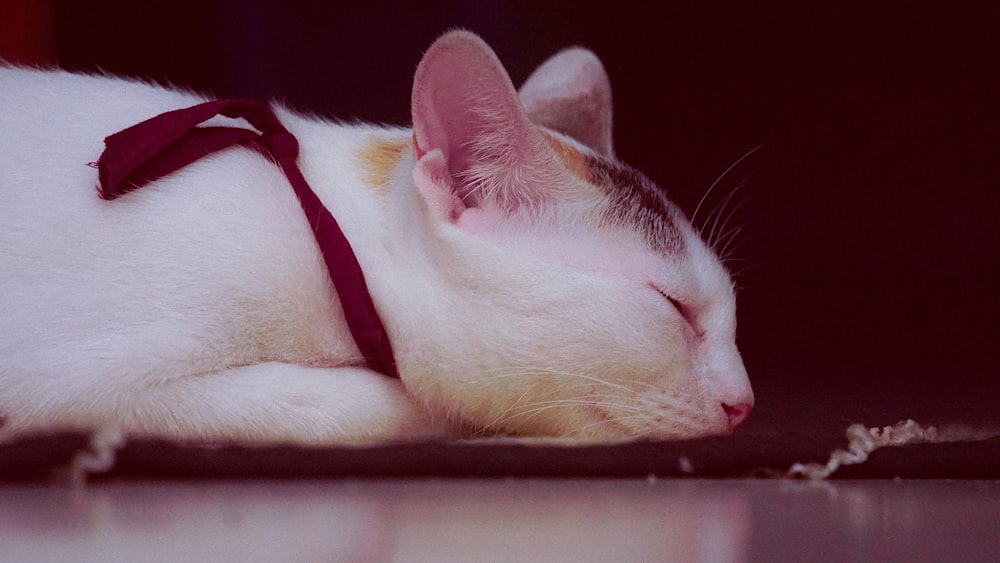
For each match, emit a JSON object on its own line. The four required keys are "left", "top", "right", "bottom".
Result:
{"left": 0, "top": 32, "right": 753, "bottom": 444}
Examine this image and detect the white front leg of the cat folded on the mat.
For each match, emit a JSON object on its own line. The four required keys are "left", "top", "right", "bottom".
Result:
{"left": 122, "top": 362, "right": 449, "bottom": 445}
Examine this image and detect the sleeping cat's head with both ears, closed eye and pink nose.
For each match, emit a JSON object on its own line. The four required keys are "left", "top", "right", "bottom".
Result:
{"left": 394, "top": 32, "right": 753, "bottom": 440}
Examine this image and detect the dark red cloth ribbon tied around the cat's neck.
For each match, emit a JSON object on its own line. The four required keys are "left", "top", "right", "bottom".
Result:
{"left": 97, "top": 100, "right": 399, "bottom": 377}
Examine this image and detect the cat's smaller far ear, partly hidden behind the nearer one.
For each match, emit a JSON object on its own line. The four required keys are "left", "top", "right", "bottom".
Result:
{"left": 520, "top": 47, "right": 614, "bottom": 157}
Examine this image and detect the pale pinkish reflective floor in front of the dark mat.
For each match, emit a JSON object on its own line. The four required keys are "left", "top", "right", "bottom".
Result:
{"left": 0, "top": 479, "right": 1000, "bottom": 562}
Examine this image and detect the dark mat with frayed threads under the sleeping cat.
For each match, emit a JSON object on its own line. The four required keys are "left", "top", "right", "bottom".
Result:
{"left": 0, "top": 433, "right": 1000, "bottom": 481}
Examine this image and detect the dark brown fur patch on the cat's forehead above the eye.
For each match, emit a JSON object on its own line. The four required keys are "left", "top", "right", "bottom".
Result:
{"left": 587, "top": 156, "right": 685, "bottom": 256}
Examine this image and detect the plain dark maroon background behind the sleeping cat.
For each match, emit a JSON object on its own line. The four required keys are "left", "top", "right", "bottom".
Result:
{"left": 0, "top": 0, "right": 1000, "bottom": 432}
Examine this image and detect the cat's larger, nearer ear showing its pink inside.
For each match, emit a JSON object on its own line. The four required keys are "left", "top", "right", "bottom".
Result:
{"left": 411, "top": 31, "right": 568, "bottom": 220}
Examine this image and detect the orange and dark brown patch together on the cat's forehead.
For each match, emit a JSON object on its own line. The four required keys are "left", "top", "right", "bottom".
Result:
{"left": 545, "top": 132, "right": 686, "bottom": 257}
